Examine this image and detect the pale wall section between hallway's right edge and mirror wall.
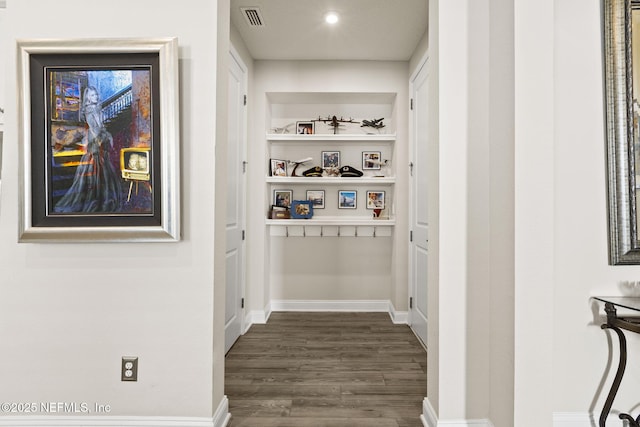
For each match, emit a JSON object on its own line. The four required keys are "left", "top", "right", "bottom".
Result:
{"left": 424, "top": 0, "right": 520, "bottom": 427}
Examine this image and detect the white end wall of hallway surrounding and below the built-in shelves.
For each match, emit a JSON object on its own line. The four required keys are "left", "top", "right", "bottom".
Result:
{"left": 247, "top": 61, "right": 409, "bottom": 311}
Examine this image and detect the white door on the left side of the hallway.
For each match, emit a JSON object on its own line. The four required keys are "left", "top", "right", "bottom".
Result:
{"left": 224, "top": 47, "right": 246, "bottom": 353}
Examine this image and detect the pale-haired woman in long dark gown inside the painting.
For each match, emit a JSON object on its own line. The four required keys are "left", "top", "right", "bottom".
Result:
{"left": 54, "top": 86, "right": 122, "bottom": 213}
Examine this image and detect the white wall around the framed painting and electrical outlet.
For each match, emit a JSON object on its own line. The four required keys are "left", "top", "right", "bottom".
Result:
{"left": 0, "top": 0, "right": 228, "bottom": 418}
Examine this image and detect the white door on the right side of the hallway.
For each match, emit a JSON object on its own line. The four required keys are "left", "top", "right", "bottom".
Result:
{"left": 409, "top": 61, "right": 429, "bottom": 346}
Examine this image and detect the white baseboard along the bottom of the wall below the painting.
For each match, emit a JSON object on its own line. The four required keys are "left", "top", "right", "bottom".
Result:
{"left": 0, "top": 415, "right": 214, "bottom": 427}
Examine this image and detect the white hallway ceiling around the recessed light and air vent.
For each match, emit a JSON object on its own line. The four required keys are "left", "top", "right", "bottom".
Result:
{"left": 231, "top": 0, "right": 428, "bottom": 61}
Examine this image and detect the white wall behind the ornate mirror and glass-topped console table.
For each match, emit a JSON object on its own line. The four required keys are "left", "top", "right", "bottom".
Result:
{"left": 546, "top": 0, "right": 640, "bottom": 414}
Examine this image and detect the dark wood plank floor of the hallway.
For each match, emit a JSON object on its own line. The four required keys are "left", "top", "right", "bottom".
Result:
{"left": 225, "top": 312, "right": 427, "bottom": 427}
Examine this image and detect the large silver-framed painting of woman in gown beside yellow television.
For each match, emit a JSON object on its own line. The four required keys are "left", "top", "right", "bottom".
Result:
{"left": 18, "top": 38, "right": 180, "bottom": 242}
